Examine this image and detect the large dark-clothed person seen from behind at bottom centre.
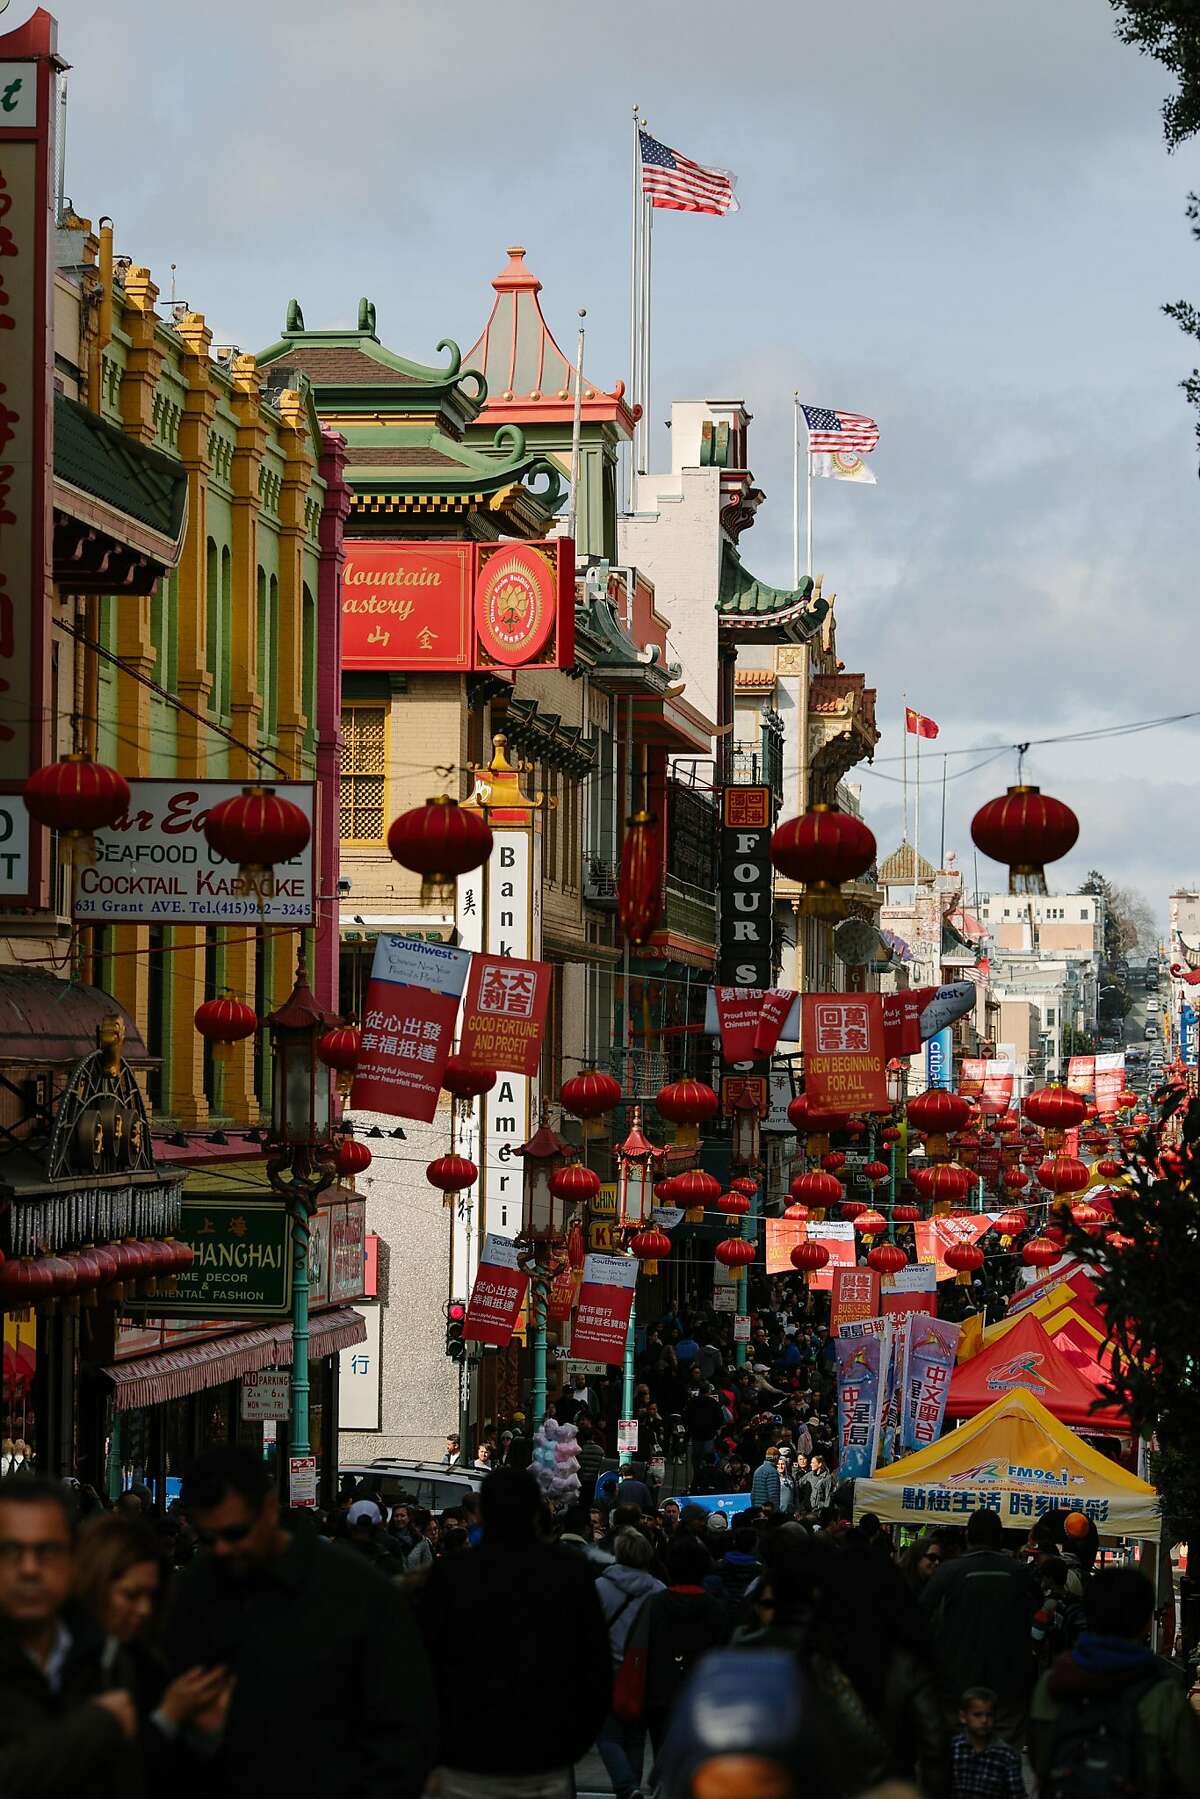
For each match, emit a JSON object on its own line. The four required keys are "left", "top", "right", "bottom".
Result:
{"left": 420, "top": 1468, "right": 612, "bottom": 1799}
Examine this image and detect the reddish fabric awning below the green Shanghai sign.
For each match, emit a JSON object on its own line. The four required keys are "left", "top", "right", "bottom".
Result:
{"left": 101, "top": 1306, "right": 367, "bottom": 1412}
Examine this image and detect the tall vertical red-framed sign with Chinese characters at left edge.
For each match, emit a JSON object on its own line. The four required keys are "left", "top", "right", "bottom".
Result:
{"left": 0, "top": 11, "right": 59, "bottom": 905}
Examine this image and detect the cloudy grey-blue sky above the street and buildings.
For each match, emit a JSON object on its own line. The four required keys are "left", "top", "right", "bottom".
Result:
{"left": 37, "top": 0, "right": 1200, "bottom": 914}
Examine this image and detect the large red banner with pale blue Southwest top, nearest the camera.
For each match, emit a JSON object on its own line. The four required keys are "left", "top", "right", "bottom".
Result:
{"left": 351, "top": 937, "right": 471, "bottom": 1124}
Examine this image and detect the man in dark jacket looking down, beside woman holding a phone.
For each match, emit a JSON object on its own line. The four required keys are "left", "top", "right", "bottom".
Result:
{"left": 166, "top": 1445, "right": 435, "bottom": 1799}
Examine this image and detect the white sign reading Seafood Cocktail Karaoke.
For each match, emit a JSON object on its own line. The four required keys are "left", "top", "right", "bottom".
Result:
{"left": 74, "top": 781, "right": 317, "bottom": 925}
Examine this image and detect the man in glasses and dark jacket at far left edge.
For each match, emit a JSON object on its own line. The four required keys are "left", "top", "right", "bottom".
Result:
{"left": 0, "top": 1477, "right": 140, "bottom": 1799}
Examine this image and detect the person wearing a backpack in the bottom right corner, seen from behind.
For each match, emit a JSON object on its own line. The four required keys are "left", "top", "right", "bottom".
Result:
{"left": 1029, "top": 1569, "right": 1200, "bottom": 1799}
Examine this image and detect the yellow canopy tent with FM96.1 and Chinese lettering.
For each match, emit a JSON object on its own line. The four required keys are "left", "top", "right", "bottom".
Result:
{"left": 855, "top": 1387, "right": 1162, "bottom": 1542}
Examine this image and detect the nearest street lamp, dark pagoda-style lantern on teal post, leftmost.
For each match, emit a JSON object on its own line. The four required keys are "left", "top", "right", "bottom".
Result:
{"left": 266, "top": 937, "right": 342, "bottom": 1455}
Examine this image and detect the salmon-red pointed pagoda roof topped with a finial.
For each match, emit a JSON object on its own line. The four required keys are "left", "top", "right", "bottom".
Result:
{"left": 466, "top": 245, "right": 633, "bottom": 437}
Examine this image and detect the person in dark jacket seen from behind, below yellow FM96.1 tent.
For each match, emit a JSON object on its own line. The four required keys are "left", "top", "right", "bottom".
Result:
{"left": 921, "top": 1511, "right": 1042, "bottom": 1749}
